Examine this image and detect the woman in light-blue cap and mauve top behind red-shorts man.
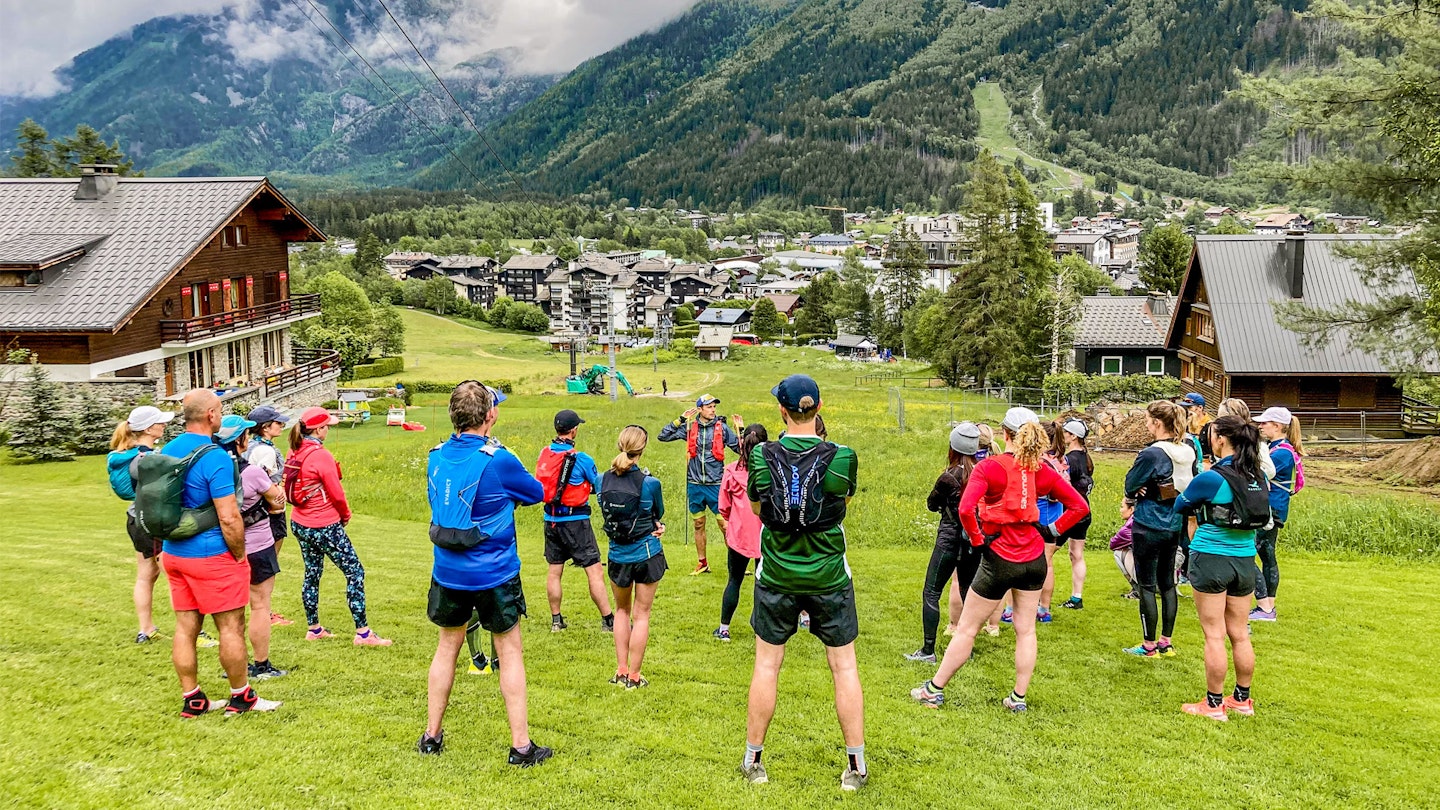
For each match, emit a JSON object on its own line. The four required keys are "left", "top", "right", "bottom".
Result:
{"left": 215, "top": 415, "right": 287, "bottom": 680}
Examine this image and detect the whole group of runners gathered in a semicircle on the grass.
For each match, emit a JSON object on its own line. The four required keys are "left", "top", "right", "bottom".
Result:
{"left": 109, "top": 375, "right": 1303, "bottom": 790}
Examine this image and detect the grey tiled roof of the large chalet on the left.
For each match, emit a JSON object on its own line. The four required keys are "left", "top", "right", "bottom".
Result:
{"left": 0, "top": 177, "right": 325, "bottom": 331}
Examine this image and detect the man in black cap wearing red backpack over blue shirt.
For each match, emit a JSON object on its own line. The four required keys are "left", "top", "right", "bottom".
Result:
{"left": 536, "top": 409, "right": 615, "bottom": 633}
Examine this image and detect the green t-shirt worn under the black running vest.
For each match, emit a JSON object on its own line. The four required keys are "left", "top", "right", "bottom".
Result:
{"left": 749, "top": 435, "right": 860, "bottom": 595}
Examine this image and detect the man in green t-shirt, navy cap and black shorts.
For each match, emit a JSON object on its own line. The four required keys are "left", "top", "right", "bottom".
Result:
{"left": 740, "top": 375, "right": 868, "bottom": 791}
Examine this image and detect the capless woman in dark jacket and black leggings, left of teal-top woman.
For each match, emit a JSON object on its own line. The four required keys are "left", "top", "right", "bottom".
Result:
{"left": 1120, "top": 399, "right": 1200, "bottom": 659}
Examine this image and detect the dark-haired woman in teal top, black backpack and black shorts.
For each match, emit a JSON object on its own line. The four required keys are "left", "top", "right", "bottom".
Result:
{"left": 1175, "top": 417, "right": 1270, "bottom": 721}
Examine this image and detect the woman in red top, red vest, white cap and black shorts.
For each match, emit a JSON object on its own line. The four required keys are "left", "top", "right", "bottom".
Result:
{"left": 910, "top": 408, "right": 1090, "bottom": 712}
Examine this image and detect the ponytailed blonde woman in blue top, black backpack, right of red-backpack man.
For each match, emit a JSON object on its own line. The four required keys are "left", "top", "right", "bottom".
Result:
{"left": 599, "top": 425, "right": 668, "bottom": 689}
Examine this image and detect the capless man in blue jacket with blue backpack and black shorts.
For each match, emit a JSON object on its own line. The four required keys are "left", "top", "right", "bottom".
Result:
{"left": 419, "top": 380, "right": 554, "bottom": 768}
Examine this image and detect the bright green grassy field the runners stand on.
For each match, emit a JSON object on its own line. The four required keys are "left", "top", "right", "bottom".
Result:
{"left": 0, "top": 314, "right": 1440, "bottom": 807}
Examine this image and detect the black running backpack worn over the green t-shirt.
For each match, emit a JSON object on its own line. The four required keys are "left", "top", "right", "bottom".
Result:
{"left": 760, "top": 441, "right": 845, "bottom": 533}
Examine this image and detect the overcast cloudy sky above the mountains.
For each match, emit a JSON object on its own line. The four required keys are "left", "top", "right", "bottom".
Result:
{"left": 0, "top": 0, "right": 696, "bottom": 95}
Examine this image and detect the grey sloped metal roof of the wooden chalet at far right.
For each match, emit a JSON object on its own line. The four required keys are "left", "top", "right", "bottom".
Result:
{"left": 1166, "top": 233, "right": 1418, "bottom": 375}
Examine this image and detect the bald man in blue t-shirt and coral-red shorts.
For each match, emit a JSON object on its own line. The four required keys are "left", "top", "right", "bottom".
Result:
{"left": 160, "top": 389, "right": 279, "bottom": 718}
